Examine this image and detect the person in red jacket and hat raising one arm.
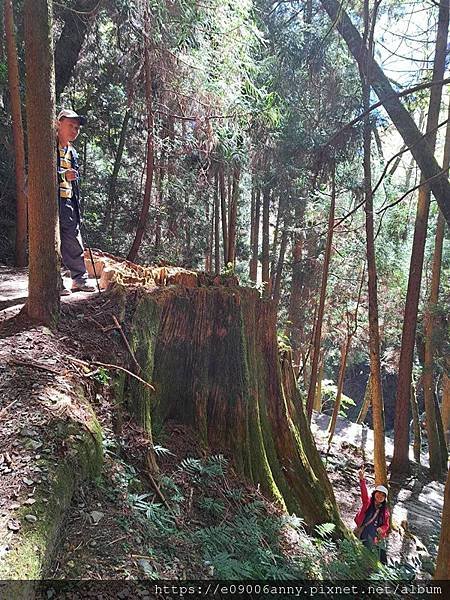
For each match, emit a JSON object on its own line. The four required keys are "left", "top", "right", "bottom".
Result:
{"left": 355, "top": 467, "right": 390, "bottom": 565}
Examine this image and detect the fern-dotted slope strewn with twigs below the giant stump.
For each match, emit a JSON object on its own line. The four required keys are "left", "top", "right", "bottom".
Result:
{"left": 43, "top": 409, "right": 412, "bottom": 580}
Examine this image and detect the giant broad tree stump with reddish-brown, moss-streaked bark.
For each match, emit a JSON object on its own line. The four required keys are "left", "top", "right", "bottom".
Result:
{"left": 114, "top": 273, "right": 346, "bottom": 535}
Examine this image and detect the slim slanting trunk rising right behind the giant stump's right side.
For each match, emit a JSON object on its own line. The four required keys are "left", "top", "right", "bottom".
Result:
{"left": 306, "top": 165, "right": 336, "bottom": 420}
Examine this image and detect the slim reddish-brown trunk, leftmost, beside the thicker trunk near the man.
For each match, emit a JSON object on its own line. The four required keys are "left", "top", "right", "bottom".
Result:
{"left": 4, "top": 0, "right": 28, "bottom": 267}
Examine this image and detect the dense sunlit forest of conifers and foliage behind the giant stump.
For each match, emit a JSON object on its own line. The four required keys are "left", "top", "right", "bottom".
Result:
{"left": 0, "top": 0, "right": 450, "bottom": 468}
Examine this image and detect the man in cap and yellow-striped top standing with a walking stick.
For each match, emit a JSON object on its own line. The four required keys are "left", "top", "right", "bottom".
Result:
{"left": 56, "top": 109, "right": 96, "bottom": 296}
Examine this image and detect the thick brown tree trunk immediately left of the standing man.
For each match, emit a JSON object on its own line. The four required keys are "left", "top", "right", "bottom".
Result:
{"left": 23, "top": 0, "right": 60, "bottom": 325}
